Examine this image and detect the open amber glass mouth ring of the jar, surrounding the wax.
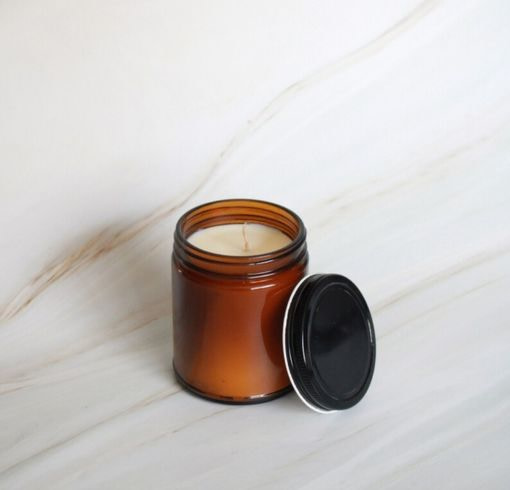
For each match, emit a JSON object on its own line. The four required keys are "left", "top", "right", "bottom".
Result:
{"left": 174, "top": 199, "right": 306, "bottom": 264}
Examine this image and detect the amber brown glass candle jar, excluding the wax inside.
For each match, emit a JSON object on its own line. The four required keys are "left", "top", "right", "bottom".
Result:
{"left": 172, "top": 199, "right": 308, "bottom": 403}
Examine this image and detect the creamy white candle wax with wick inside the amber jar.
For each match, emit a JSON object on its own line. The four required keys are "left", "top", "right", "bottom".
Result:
{"left": 188, "top": 223, "right": 291, "bottom": 256}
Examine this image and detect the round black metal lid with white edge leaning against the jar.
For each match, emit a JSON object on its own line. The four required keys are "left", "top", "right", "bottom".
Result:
{"left": 283, "top": 274, "right": 375, "bottom": 413}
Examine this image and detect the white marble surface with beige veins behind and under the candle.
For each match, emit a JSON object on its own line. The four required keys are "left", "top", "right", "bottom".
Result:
{"left": 0, "top": 0, "right": 510, "bottom": 490}
